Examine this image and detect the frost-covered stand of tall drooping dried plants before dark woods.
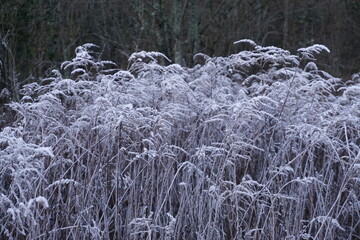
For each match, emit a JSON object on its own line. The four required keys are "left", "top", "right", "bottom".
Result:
{"left": 0, "top": 40, "right": 360, "bottom": 240}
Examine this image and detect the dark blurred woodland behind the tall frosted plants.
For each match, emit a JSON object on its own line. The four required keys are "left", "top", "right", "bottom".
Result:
{"left": 0, "top": 0, "right": 360, "bottom": 99}
